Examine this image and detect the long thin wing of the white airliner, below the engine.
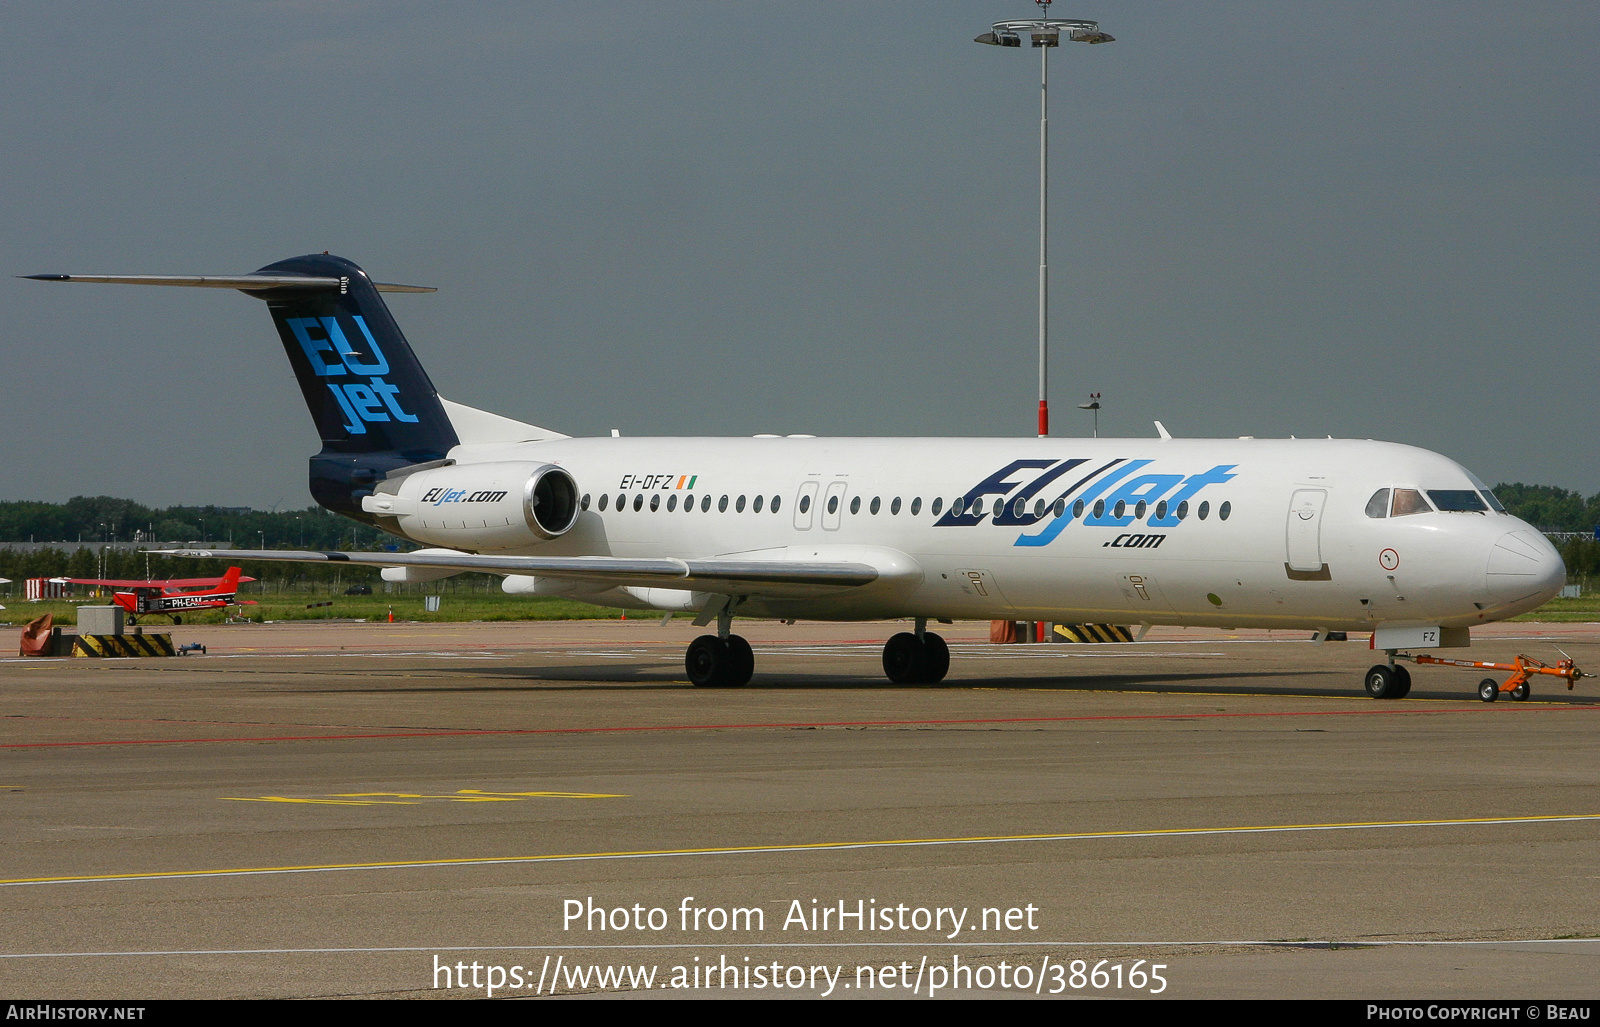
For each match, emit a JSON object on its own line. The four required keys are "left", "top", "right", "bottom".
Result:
{"left": 162, "top": 549, "right": 880, "bottom": 597}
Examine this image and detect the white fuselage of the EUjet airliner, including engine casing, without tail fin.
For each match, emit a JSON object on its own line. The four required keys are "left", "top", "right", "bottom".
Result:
{"left": 377, "top": 437, "right": 1565, "bottom": 630}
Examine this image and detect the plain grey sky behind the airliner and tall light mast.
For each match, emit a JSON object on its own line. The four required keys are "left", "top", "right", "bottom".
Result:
{"left": 0, "top": 0, "right": 1600, "bottom": 507}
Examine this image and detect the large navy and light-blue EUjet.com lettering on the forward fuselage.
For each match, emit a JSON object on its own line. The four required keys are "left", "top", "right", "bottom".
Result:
{"left": 934, "top": 458, "right": 1238, "bottom": 549}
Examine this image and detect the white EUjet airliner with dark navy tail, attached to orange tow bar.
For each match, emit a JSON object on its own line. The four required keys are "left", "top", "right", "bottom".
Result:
{"left": 32, "top": 254, "right": 1565, "bottom": 699}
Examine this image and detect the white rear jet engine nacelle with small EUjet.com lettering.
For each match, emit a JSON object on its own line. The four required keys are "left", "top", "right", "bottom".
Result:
{"left": 362, "top": 462, "right": 578, "bottom": 552}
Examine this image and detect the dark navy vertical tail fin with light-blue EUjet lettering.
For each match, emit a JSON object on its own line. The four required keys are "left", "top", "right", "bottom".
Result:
{"left": 250, "top": 254, "right": 459, "bottom": 520}
